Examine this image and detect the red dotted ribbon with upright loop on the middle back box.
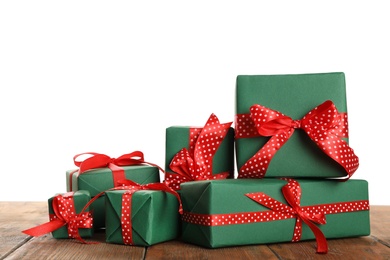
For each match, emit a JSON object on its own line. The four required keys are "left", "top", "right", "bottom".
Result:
{"left": 165, "top": 114, "right": 233, "bottom": 190}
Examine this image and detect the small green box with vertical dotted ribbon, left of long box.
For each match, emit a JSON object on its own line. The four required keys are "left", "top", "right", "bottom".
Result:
{"left": 105, "top": 190, "right": 180, "bottom": 246}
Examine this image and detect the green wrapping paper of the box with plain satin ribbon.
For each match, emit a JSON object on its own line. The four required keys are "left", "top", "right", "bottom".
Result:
{"left": 66, "top": 165, "right": 160, "bottom": 228}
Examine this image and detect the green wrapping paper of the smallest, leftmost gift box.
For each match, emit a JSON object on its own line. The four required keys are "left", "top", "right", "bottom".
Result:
{"left": 48, "top": 190, "right": 93, "bottom": 239}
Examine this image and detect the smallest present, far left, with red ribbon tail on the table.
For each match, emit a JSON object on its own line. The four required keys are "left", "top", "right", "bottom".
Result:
{"left": 23, "top": 190, "right": 93, "bottom": 243}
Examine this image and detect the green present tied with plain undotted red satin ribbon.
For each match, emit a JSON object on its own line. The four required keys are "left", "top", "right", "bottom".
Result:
{"left": 66, "top": 151, "right": 162, "bottom": 228}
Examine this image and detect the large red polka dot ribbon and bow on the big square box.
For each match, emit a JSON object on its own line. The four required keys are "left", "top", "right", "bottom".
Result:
{"left": 236, "top": 100, "right": 359, "bottom": 179}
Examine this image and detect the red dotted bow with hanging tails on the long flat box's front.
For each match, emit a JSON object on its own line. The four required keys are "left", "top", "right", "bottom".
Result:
{"left": 246, "top": 179, "right": 328, "bottom": 254}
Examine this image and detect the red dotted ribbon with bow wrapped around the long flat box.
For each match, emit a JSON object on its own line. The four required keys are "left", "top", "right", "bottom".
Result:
{"left": 182, "top": 179, "right": 369, "bottom": 253}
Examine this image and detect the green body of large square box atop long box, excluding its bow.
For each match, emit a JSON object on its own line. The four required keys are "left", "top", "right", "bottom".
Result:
{"left": 235, "top": 72, "right": 358, "bottom": 178}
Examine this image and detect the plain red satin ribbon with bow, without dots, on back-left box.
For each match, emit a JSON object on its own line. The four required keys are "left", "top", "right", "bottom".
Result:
{"left": 69, "top": 151, "right": 164, "bottom": 190}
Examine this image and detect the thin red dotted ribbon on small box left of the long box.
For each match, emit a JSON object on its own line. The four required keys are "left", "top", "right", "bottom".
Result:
{"left": 113, "top": 180, "right": 183, "bottom": 245}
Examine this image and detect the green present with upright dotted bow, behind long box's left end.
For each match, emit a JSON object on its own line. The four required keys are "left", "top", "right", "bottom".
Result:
{"left": 165, "top": 114, "right": 234, "bottom": 190}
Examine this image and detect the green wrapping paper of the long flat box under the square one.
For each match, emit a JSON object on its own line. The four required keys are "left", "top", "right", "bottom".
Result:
{"left": 180, "top": 178, "right": 370, "bottom": 248}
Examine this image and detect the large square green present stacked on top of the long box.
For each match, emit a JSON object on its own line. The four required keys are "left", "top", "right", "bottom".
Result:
{"left": 235, "top": 73, "right": 359, "bottom": 179}
